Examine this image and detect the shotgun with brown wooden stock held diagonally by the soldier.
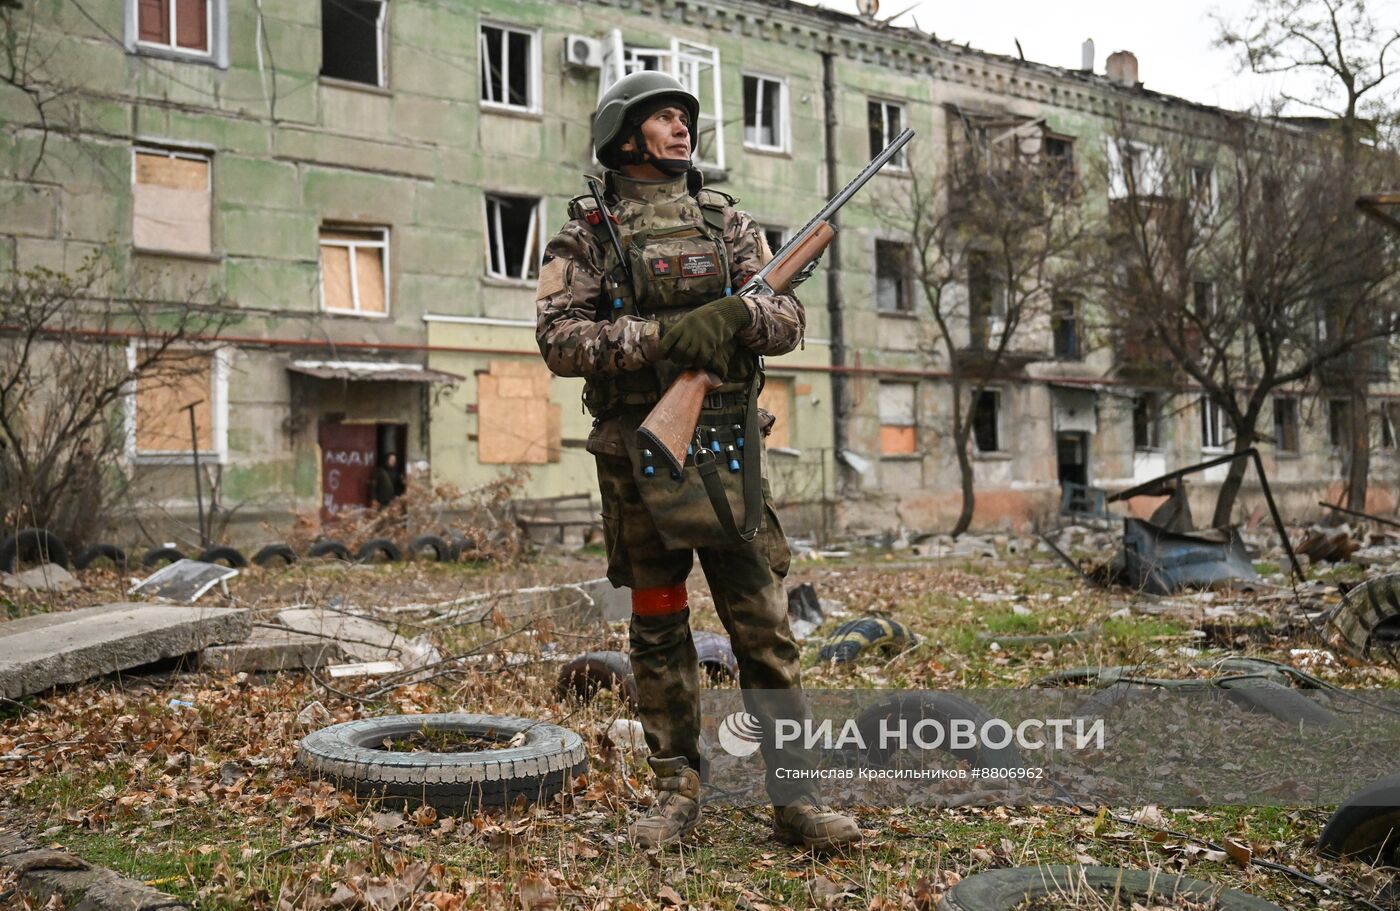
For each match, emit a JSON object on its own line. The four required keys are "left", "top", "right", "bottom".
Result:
{"left": 637, "top": 130, "right": 914, "bottom": 472}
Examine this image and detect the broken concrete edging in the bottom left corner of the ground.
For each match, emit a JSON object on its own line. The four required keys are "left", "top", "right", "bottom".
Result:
{"left": 0, "top": 830, "right": 189, "bottom": 911}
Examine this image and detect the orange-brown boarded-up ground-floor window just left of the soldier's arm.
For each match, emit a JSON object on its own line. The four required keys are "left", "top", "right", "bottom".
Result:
{"left": 476, "top": 361, "right": 563, "bottom": 465}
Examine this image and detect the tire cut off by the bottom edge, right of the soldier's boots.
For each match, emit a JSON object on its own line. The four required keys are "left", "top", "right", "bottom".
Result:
{"left": 938, "top": 865, "right": 1282, "bottom": 911}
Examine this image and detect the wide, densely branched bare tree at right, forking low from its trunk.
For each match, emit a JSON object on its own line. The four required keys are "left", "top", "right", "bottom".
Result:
{"left": 1096, "top": 116, "right": 1400, "bottom": 526}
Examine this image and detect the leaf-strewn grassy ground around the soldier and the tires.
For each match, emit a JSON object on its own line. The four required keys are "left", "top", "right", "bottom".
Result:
{"left": 0, "top": 551, "right": 1400, "bottom": 911}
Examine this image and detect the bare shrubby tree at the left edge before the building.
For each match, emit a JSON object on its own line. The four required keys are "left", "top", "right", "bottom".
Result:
{"left": 0, "top": 256, "right": 227, "bottom": 543}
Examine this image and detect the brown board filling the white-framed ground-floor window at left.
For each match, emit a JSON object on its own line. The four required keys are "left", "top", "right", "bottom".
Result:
{"left": 136, "top": 353, "right": 214, "bottom": 455}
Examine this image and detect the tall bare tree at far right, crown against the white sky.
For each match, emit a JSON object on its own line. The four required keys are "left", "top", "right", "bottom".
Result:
{"left": 1219, "top": 0, "right": 1400, "bottom": 509}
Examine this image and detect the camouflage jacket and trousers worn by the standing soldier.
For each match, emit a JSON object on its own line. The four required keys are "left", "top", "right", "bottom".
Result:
{"left": 536, "top": 175, "right": 811, "bottom": 805}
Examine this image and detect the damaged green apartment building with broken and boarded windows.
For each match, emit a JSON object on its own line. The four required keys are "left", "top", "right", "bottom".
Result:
{"left": 0, "top": 0, "right": 1394, "bottom": 537}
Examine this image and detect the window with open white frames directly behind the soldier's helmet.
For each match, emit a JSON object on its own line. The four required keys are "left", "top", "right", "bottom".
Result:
{"left": 598, "top": 28, "right": 724, "bottom": 168}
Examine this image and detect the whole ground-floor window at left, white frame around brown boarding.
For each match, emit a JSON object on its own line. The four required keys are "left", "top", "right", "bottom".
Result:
{"left": 127, "top": 347, "right": 228, "bottom": 460}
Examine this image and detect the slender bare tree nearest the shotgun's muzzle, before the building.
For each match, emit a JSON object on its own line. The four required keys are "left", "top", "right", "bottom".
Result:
{"left": 879, "top": 118, "right": 1089, "bottom": 536}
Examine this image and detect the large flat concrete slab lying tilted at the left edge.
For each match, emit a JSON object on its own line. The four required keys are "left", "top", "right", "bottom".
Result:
{"left": 0, "top": 602, "right": 252, "bottom": 698}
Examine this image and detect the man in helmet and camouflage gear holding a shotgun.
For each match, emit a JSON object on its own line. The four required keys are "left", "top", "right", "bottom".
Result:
{"left": 536, "top": 71, "right": 860, "bottom": 849}
